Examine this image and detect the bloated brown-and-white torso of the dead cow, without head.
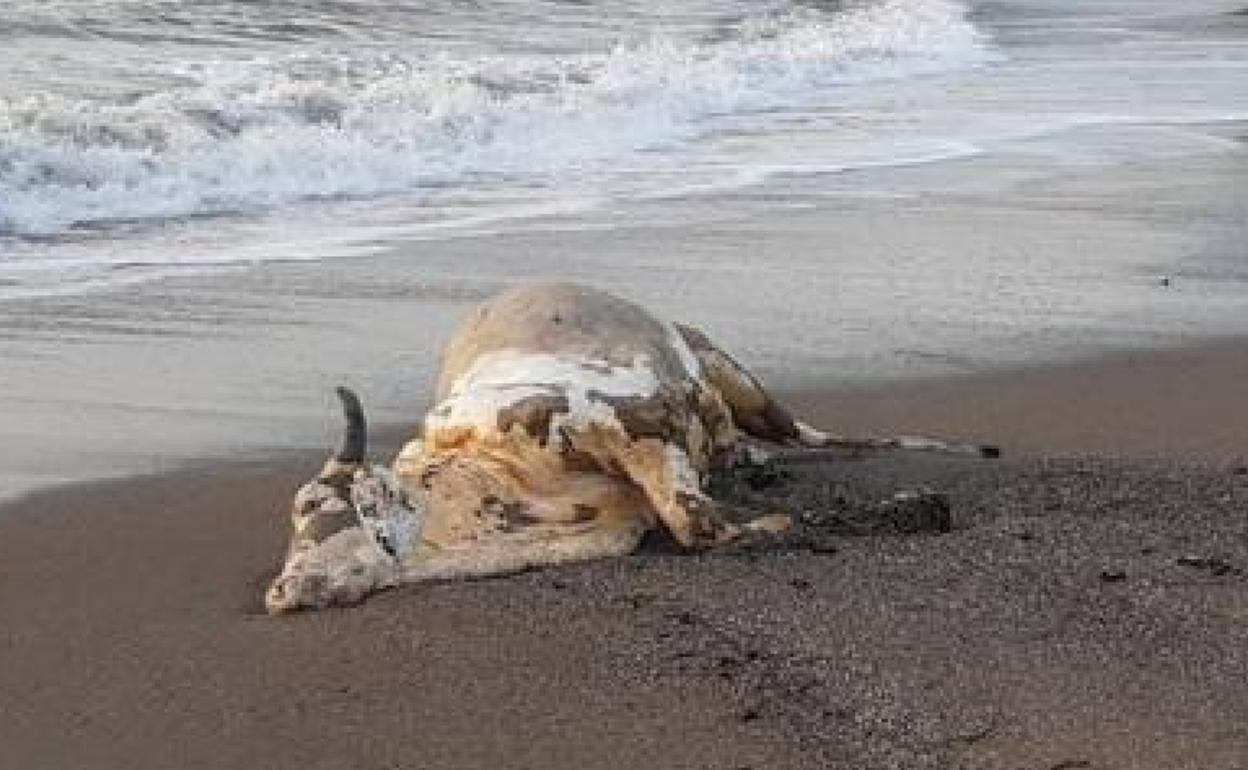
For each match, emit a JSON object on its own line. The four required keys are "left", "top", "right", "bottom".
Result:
{"left": 396, "top": 285, "right": 733, "bottom": 571}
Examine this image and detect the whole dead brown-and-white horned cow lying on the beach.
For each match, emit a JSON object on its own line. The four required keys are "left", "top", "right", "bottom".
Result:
{"left": 266, "top": 283, "right": 983, "bottom": 613}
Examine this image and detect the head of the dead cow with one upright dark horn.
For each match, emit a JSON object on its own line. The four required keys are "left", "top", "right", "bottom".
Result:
{"left": 265, "top": 388, "right": 422, "bottom": 614}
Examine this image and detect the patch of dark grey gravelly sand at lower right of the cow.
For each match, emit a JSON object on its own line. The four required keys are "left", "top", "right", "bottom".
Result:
{"left": 514, "top": 457, "right": 1248, "bottom": 770}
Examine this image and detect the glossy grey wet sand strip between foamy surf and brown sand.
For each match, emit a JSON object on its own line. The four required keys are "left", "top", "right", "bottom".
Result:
{"left": 0, "top": 114, "right": 1248, "bottom": 499}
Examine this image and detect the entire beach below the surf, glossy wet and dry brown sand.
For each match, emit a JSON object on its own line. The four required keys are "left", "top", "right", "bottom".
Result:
{"left": 0, "top": 127, "right": 1248, "bottom": 770}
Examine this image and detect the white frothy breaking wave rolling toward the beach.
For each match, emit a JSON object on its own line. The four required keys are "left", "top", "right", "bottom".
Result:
{"left": 0, "top": 0, "right": 986, "bottom": 236}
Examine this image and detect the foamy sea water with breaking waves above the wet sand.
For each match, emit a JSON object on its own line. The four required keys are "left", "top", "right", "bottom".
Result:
{"left": 0, "top": 0, "right": 1248, "bottom": 297}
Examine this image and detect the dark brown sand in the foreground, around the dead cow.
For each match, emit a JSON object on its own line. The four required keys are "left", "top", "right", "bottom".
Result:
{"left": 0, "top": 344, "right": 1248, "bottom": 770}
